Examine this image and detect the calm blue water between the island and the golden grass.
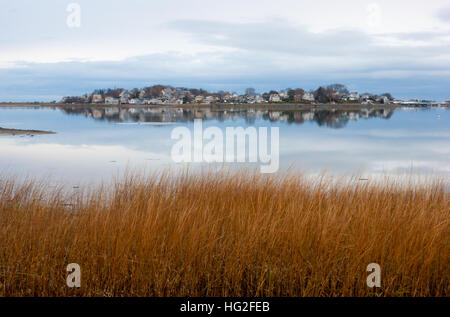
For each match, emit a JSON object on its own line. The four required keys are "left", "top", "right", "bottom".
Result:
{"left": 0, "top": 108, "right": 450, "bottom": 183}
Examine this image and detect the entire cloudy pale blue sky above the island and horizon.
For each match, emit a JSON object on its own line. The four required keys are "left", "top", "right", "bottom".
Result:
{"left": 0, "top": 0, "right": 450, "bottom": 101}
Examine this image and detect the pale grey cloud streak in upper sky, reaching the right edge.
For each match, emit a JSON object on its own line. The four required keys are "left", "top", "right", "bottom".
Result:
{"left": 167, "top": 20, "right": 450, "bottom": 58}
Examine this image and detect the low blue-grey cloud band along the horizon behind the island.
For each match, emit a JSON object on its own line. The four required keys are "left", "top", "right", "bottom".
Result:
{"left": 0, "top": 51, "right": 450, "bottom": 101}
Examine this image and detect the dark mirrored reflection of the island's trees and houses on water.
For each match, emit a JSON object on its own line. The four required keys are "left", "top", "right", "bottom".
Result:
{"left": 61, "top": 107, "right": 394, "bottom": 129}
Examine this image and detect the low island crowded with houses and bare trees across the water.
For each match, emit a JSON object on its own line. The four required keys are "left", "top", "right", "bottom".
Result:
{"left": 61, "top": 85, "right": 436, "bottom": 105}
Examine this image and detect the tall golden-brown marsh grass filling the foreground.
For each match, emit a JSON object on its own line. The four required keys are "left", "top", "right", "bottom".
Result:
{"left": 0, "top": 173, "right": 450, "bottom": 296}
